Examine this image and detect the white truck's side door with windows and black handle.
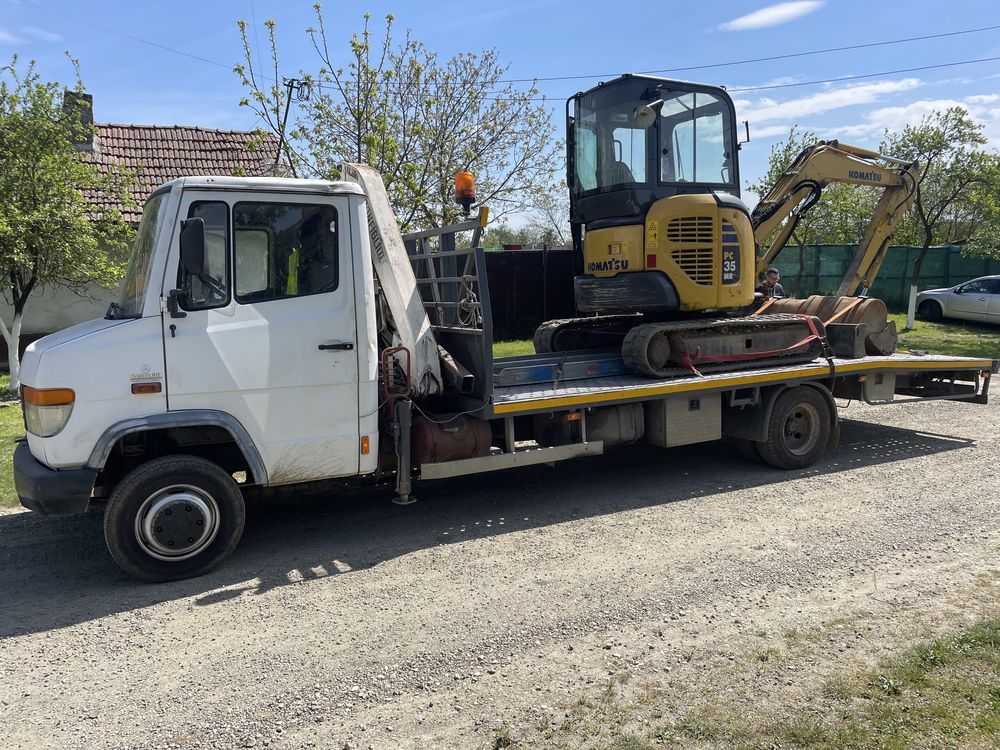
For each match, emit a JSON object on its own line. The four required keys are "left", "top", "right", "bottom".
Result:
{"left": 163, "top": 191, "right": 360, "bottom": 484}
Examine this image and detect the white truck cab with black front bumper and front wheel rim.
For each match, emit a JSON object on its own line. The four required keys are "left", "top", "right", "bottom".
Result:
{"left": 15, "top": 177, "right": 379, "bottom": 574}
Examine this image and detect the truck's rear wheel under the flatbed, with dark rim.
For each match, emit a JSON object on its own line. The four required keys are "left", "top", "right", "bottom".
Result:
{"left": 757, "top": 385, "right": 832, "bottom": 469}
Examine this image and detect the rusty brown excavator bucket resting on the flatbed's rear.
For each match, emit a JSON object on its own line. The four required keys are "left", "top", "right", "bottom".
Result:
{"left": 760, "top": 294, "right": 898, "bottom": 358}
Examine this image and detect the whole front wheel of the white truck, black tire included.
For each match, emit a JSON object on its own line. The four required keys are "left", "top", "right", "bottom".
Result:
{"left": 104, "top": 456, "right": 246, "bottom": 582}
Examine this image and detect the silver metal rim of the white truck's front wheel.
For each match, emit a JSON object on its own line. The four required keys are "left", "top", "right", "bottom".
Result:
{"left": 135, "top": 484, "right": 219, "bottom": 562}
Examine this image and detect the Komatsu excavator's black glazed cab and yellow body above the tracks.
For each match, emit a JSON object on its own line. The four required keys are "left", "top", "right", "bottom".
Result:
{"left": 566, "top": 75, "right": 756, "bottom": 317}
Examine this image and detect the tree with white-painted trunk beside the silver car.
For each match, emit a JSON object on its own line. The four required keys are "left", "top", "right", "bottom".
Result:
{"left": 882, "top": 107, "right": 996, "bottom": 329}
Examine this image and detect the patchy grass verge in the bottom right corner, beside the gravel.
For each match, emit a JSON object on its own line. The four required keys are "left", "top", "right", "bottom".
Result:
{"left": 504, "top": 617, "right": 1000, "bottom": 750}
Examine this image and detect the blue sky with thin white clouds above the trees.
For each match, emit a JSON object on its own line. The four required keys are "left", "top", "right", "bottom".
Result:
{"left": 0, "top": 0, "right": 1000, "bottom": 209}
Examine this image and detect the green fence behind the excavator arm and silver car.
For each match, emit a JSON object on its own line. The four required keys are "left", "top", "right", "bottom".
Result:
{"left": 772, "top": 245, "right": 1000, "bottom": 310}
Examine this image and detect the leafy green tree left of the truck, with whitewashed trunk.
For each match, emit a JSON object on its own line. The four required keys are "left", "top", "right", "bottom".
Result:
{"left": 0, "top": 56, "right": 132, "bottom": 389}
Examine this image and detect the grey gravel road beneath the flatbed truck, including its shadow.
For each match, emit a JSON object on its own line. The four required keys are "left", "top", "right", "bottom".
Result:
{"left": 0, "top": 394, "right": 1000, "bottom": 750}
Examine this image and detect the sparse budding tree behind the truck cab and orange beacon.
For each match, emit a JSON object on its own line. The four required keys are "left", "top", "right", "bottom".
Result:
{"left": 235, "top": 4, "right": 561, "bottom": 231}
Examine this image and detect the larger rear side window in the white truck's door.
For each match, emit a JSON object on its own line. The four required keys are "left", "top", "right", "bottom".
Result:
{"left": 233, "top": 202, "right": 339, "bottom": 303}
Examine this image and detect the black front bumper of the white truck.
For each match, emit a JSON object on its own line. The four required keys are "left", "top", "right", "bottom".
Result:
{"left": 14, "top": 443, "right": 97, "bottom": 516}
